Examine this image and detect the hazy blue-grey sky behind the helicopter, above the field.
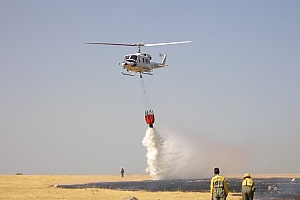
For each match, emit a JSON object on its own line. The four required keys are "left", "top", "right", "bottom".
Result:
{"left": 0, "top": 0, "right": 300, "bottom": 178}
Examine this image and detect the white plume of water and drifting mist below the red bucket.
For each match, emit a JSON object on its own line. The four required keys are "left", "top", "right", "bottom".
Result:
{"left": 142, "top": 128, "right": 250, "bottom": 180}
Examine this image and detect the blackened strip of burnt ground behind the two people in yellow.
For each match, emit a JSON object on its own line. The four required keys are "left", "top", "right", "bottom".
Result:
{"left": 58, "top": 178, "right": 300, "bottom": 199}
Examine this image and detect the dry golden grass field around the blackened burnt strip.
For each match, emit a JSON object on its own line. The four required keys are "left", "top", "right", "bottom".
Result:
{"left": 0, "top": 174, "right": 300, "bottom": 200}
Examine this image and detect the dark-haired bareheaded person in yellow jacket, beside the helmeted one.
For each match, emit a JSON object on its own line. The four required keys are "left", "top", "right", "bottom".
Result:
{"left": 210, "top": 168, "right": 228, "bottom": 200}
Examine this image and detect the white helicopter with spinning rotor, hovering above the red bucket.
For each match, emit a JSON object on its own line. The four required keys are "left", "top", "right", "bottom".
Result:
{"left": 85, "top": 41, "right": 191, "bottom": 76}
